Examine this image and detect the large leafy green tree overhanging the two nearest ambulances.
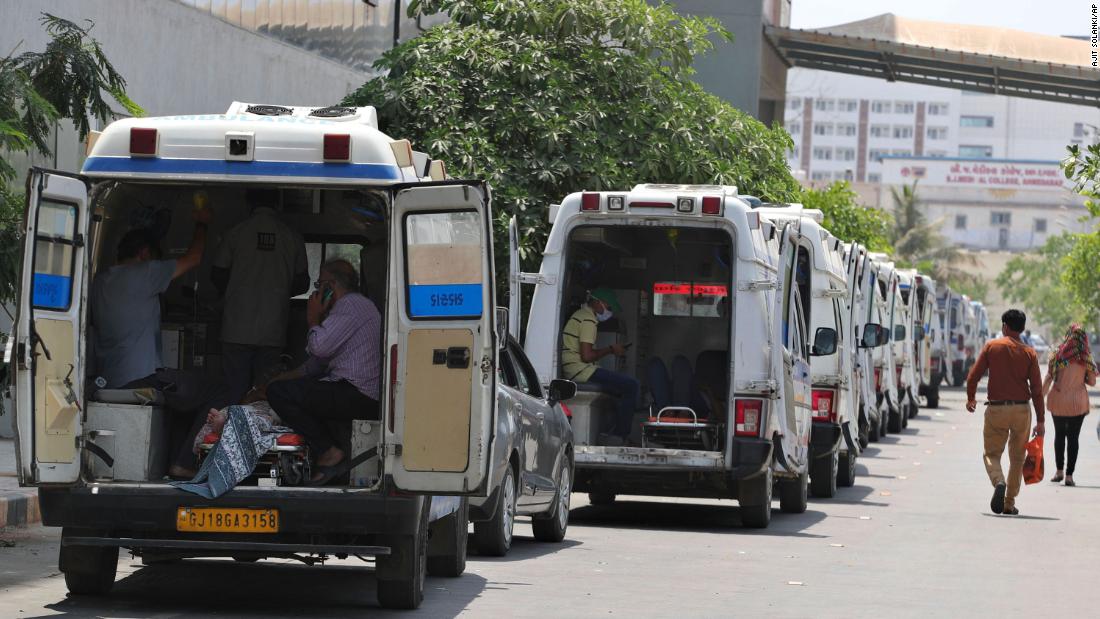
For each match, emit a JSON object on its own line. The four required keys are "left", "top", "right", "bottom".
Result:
{"left": 345, "top": 0, "right": 800, "bottom": 271}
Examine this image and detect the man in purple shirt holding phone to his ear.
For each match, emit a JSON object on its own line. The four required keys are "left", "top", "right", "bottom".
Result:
{"left": 267, "top": 259, "right": 382, "bottom": 486}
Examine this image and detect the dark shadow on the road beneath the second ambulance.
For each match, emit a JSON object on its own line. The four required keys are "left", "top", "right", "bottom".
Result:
{"left": 570, "top": 499, "right": 827, "bottom": 539}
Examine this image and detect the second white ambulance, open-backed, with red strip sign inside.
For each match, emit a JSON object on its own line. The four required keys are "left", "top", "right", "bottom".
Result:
{"left": 520, "top": 185, "right": 824, "bottom": 528}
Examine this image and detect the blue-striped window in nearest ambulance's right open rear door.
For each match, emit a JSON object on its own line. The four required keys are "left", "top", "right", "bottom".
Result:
{"left": 405, "top": 211, "right": 484, "bottom": 318}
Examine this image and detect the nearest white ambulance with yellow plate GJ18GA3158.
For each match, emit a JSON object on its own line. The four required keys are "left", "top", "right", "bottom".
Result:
{"left": 8, "top": 102, "right": 505, "bottom": 608}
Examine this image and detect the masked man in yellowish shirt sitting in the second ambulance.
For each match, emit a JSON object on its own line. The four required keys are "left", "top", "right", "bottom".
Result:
{"left": 561, "top": 288, "right": 638, "bottom": 446}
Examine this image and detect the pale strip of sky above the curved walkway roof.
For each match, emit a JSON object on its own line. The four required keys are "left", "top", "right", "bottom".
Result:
{"left": 791, "top": 0, "right": 1092, "bottom": 36}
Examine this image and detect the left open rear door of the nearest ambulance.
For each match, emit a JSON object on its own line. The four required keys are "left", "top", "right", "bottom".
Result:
{"left": 10, "top": 169, "right": 90, "bottom": 486}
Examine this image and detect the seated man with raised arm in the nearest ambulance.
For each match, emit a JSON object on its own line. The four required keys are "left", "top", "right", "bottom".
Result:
{"left": 91, "top": 203, "right": 229, "bottom": 478}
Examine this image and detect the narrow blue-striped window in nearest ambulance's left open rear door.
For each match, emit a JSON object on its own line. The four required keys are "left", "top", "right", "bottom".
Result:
{"left": 31, "top": 200, "right": 77, "bottom": 311}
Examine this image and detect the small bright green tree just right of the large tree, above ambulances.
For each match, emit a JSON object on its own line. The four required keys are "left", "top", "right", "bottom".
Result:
{"left": 801, "top": 180, "right": 892, "bottom": 253}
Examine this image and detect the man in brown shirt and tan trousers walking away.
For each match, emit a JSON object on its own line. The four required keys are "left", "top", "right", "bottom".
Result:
{"left": 966, "top": 309, "right": 1045, "bottom": 516}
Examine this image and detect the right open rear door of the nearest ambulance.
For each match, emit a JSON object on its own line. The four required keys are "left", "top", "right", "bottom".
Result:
{"left": 386, "top": 183, "right": 496, "bottom": 496}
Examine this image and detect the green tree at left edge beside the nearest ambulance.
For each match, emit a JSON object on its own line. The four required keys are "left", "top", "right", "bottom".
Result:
{"left": 0, "top": 13, "right": 143, "bottom": 303}
